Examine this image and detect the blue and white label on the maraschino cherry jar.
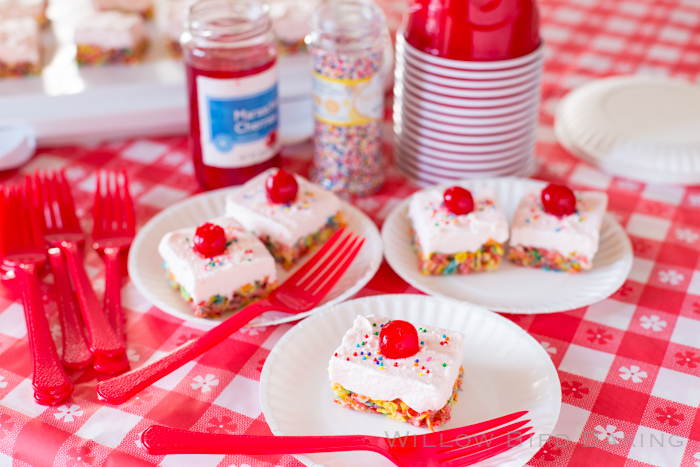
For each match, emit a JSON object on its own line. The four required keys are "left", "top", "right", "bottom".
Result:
{"left": 197, "top": 64, "right": 280, "bottom": 168}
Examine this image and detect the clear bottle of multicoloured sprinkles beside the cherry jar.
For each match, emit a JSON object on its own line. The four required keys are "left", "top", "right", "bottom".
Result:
{"left": 306, "top": 0, "right": 388, "bottom": 198}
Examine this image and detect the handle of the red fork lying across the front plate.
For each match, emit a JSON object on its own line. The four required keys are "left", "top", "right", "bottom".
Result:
{"left": 141, "top": 425, "right": 382, "bottom": 455}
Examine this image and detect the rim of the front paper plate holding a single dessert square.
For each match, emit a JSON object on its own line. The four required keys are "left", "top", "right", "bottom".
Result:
{"left": 259, "top": 293, "right": 563, "bottom": 467}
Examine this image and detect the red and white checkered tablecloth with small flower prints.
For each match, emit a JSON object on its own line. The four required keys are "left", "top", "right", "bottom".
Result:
{"left": 0, "top": 0, "right": 700, "bottom": 467}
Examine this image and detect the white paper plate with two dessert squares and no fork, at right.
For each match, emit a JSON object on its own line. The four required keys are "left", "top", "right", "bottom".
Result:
{"left": 382, "top": 178, "right": 632, "bottom": 314}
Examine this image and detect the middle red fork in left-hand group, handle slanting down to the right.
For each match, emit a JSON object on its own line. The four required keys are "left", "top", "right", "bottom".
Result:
{"left": 27, "top": 172, "right": 129, "bottom": 374}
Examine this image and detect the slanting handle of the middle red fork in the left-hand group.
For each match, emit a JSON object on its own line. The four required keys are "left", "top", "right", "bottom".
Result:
{"left": 61, "top": 241, "right": 124, "bottom": 357}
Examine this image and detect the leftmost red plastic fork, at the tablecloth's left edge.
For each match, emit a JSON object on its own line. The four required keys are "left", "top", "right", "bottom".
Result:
{"left": 0, "top": 188, "right": 73, "bottom": 405}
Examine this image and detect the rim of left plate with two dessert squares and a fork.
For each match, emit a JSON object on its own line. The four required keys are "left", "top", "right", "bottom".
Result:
{"left": 127, "top": 185, "right": 384, "bottom": 327}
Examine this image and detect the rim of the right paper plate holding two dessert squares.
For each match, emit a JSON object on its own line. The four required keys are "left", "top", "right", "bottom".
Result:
{"left": 382, "top": 176, "right": 634, "bottom": 315}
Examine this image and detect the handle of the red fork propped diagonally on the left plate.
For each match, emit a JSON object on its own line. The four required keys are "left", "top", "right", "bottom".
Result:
{"left": 97, "top": 299, "right": 277, "bottom": 404}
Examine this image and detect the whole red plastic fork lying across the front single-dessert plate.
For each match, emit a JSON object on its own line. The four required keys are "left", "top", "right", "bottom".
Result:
{"left": 141, "top": 412, "right": 533, "bottom": 467}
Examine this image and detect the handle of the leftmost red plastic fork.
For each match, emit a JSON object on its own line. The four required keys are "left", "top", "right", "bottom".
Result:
{"left": 15, "top": 264, "right": 73, "bottom": 405}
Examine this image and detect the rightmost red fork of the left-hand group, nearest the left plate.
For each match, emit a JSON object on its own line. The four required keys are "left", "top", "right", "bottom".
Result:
{"left": 92, "top": 171, "right": 136, "bottom": 340}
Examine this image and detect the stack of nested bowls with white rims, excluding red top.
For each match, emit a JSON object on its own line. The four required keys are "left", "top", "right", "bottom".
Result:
{"left": 394, "top": 31, "right": 544, "bottom": 185}
